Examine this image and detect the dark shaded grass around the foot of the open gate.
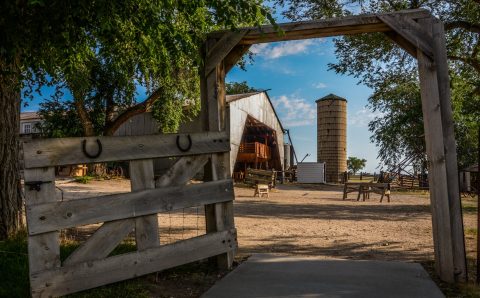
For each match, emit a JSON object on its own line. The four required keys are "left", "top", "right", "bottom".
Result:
{"left": 0, "top": 231, "right": 226, "bottom": 298}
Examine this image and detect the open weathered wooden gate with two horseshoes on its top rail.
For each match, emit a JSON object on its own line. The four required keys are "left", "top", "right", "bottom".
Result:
{"left": 24, "top": 132, "right": 237, "bottom": 297}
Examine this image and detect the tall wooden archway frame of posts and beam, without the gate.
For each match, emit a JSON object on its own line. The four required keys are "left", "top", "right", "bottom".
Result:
{"left": 201, "top": 10, "right": 466, "bottom": 282}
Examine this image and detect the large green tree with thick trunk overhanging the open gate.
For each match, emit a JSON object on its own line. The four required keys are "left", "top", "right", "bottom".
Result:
{"left": 0, "top": 0, "right": 273, "bottom": 239}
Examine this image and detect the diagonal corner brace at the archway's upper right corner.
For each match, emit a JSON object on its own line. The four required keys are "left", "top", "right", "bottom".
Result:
{"left": 378, "top": 15, "right": 433, "bottom": 60}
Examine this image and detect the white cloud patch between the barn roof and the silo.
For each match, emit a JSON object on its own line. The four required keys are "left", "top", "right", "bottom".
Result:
{"left": 272, "top": 95, "right": 316, "bottom": 127}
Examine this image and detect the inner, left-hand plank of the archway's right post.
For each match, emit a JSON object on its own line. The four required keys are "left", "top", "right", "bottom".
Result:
{"left": 417, "top": 20, "right": 455, "bottom": 282}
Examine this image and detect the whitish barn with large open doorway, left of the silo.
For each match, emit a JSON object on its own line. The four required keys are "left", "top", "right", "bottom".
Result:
{"left": 115, "top": 91, "right": 285, "bottom": 174}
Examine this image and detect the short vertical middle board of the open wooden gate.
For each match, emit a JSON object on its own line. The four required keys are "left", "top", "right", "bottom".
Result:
{"left": 129, "top": 159, "right": 160, "bottom": 250}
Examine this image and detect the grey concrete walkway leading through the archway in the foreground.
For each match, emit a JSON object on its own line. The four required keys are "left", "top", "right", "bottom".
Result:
{"left": 202, "top": 254, "right": 444, "bottom": 298}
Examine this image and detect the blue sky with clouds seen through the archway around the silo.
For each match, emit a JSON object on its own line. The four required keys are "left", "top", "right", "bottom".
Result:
{"left": 227, "top": 38, "right": 378, "bottom": 172}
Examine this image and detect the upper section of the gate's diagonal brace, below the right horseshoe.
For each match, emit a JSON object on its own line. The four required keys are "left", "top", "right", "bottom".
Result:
{"left": 155, "top": 155, "right": 208, "bottom": 187}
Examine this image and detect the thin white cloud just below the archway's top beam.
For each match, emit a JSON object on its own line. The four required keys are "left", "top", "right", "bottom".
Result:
{"left": 250, "top": 39, "right": 321, "bottom": 59}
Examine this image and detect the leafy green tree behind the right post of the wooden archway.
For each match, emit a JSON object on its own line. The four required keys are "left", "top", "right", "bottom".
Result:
{"left": 277, "top": 0, "right": 480, "bottom": 167}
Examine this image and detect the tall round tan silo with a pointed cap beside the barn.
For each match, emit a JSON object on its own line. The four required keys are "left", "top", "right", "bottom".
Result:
{"left": 316, "top": 94, "right": 347, "bottom": 183}
